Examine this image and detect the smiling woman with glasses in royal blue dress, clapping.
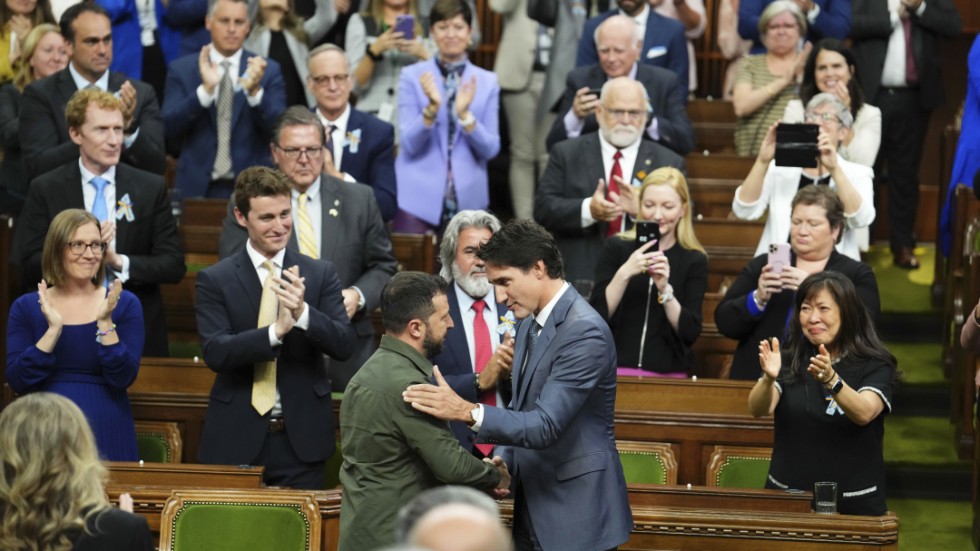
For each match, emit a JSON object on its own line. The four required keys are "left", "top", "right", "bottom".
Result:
{"left": 7, "top": 209, "right": 143, "bottom": 461}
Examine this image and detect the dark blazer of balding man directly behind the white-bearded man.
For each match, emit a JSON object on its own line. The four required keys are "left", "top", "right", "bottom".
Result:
{"left": 546, "top": 63, "right": 694, "bottom": 155}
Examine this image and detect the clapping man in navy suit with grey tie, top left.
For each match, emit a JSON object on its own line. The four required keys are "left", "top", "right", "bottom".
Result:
{"left": 163, "top": 0, "right": 286, "bottom": 199}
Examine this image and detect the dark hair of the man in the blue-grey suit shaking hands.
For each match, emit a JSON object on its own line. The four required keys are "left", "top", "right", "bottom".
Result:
{"left": 476, "top": 220, "right": 565, "bottom": 279}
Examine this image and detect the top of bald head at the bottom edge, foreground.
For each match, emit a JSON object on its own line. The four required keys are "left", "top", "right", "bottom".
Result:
{"left": 409, "top": 503, "right": 513, "bottom": 551}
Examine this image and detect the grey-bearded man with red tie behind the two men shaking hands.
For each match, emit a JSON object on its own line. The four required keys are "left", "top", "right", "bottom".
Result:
{"left": 430, "top": 210, "right": 514, "bottom": 458}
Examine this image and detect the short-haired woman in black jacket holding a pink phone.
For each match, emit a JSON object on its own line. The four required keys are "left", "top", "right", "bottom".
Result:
{"left": 715, "top": 186, "right": 881, "bottom": 380}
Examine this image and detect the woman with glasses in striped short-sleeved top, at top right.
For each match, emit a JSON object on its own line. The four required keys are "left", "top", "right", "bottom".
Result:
{"left": 732, "top": 0, "right": 810, "bottom": 156}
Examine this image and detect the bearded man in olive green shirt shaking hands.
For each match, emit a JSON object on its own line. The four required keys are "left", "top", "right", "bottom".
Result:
{"left": 340, "top": 272, "right": 510, "bottom": 551}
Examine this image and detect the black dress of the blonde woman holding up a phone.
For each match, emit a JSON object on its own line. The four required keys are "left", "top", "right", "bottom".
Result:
{"left": 590, "top": 237, "right": 708, "bottom": 373}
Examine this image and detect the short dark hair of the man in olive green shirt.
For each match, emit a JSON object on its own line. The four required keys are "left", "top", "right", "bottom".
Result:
{"left": 381, "top": 272, "right": 448, "bottom": 335}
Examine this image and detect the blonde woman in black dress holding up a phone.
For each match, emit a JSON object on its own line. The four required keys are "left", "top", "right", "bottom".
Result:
{"left": 591, "top": 167, "right": 708, "bottom": 377}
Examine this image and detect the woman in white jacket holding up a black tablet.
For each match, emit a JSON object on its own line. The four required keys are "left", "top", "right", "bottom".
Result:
{"left": 732, "top": 93, "right": 875, "bottom": 260}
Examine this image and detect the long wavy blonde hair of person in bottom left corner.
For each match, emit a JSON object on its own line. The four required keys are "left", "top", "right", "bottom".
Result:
{"left": 0, "top": 392, "right": 109, "bottom": 551}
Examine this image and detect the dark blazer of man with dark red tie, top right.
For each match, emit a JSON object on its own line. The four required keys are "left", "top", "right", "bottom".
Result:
{"left": 851, "top": 0, "right": 963, "bottom": 110}
